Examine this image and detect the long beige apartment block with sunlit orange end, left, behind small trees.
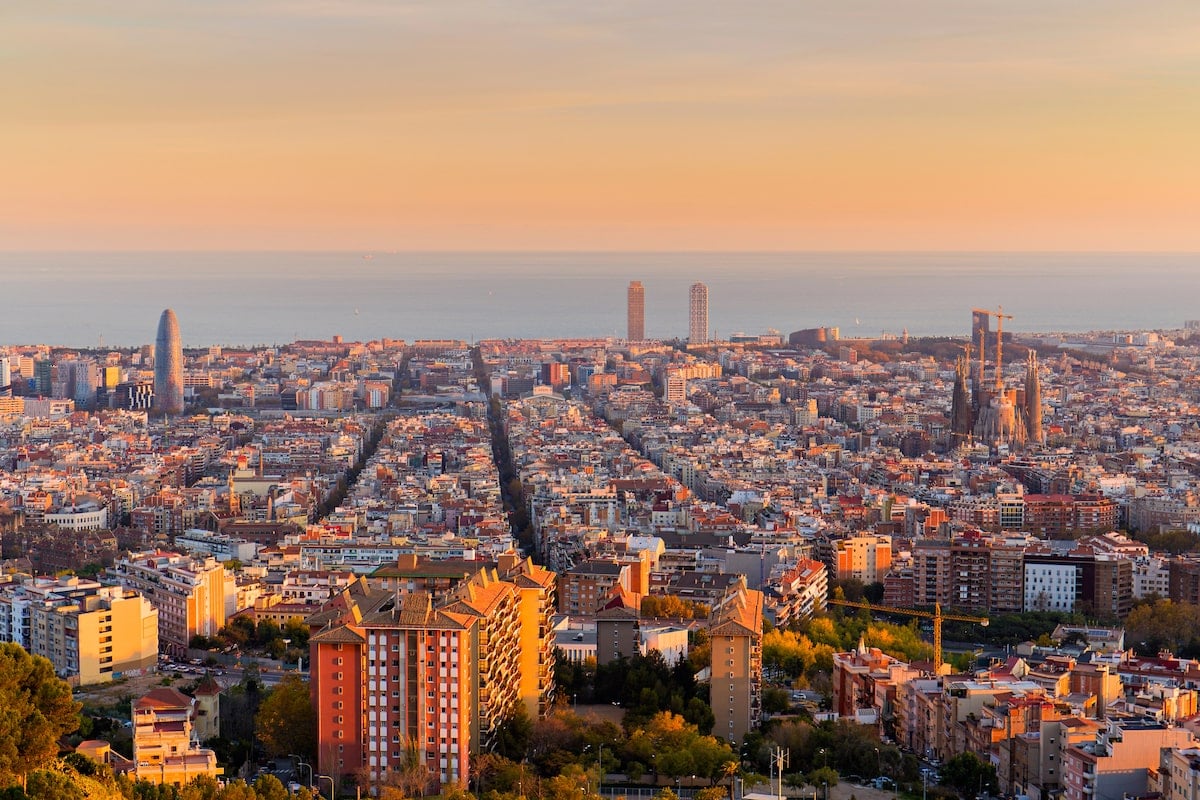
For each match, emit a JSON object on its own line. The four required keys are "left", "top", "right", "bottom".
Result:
{"left": 110, "top": 552, "right": 238, "bottom": 657}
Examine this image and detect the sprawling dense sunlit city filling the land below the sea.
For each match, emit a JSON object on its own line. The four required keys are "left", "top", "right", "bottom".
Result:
{"left": 7, "top": 293, "right": 1200, "bottom": 800}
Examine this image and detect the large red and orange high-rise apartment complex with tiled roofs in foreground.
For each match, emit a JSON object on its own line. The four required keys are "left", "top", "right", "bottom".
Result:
{"left": 307, "top": 554, "right": 554, "bottom": 789}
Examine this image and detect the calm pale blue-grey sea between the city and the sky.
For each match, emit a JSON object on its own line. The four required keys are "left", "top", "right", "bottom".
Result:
{"left": 0, "top": 252, "right": 1200, "bottom": 348}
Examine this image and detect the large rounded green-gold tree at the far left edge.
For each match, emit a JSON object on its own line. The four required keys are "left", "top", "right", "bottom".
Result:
{"left": 0, "top": 642, "right": 82, "bottom": 784}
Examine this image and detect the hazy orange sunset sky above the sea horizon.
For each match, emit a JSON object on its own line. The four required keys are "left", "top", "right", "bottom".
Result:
{"left": 0, "top": 0, "right": 1200, "bottom": 251}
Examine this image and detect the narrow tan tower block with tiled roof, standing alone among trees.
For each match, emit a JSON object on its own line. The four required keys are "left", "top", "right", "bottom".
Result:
{"left": 708, "top": 588, "right": 762, "bottom": 742}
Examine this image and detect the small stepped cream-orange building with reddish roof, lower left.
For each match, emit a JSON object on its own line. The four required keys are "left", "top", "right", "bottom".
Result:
{"left": 133, "top": 686, "right": 222, "bottom": 786}
